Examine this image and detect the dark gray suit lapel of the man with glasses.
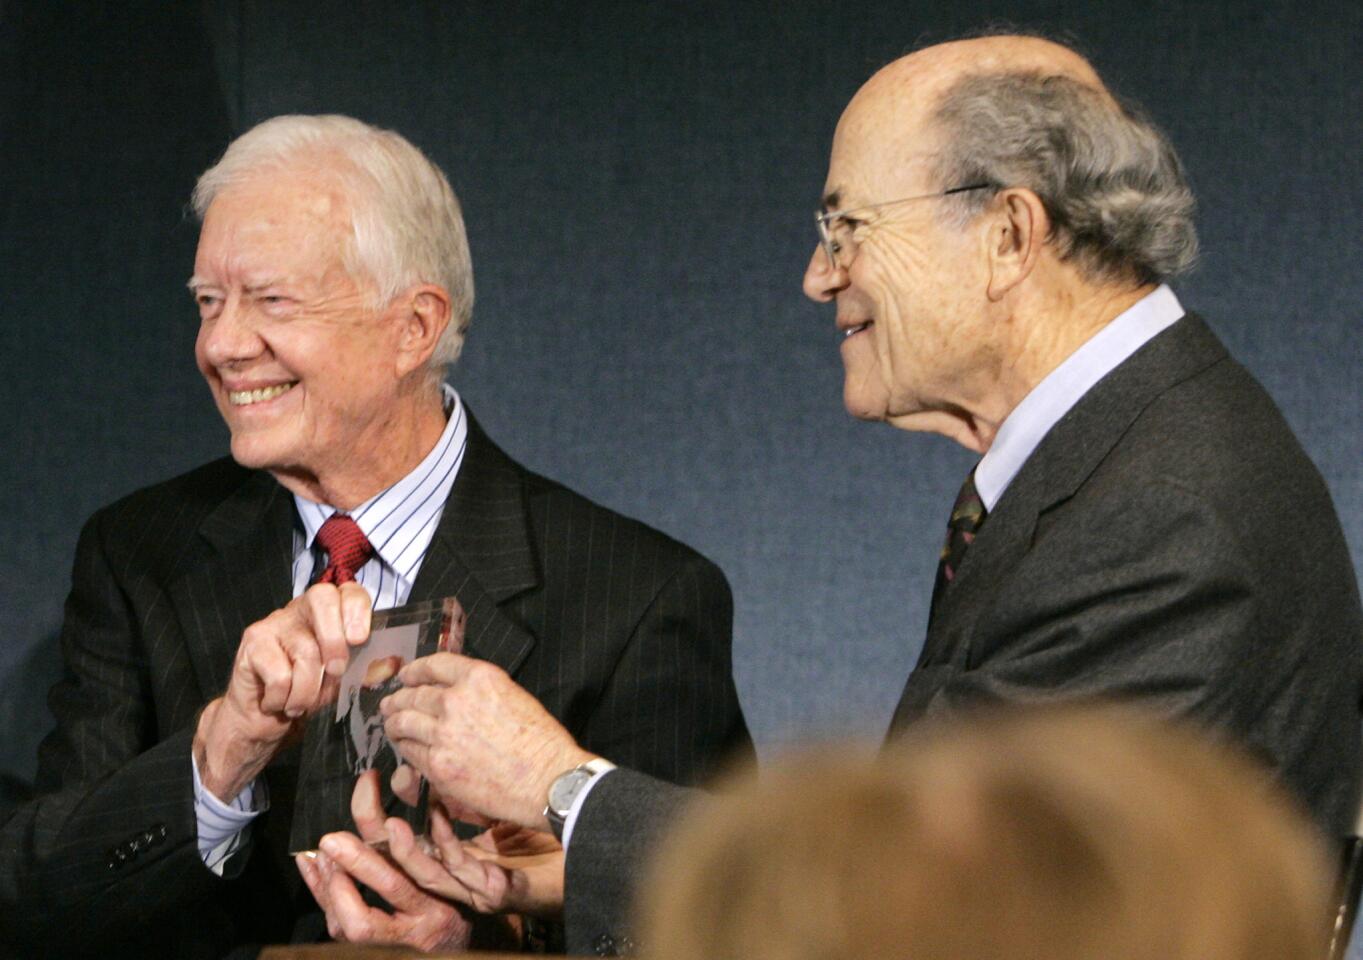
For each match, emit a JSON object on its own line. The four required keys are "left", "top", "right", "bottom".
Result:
{"left": 919, "top": 314, "right": 1227, "bottom": 667}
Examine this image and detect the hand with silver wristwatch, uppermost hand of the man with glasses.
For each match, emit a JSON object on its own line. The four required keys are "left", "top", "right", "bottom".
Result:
{"left": 380, "top": 653, "right": 594, "bottom": 830}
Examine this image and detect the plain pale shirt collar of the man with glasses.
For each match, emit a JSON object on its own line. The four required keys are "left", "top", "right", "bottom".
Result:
{"left": 975, "top": 284, "right": 1183, "bottom": 510}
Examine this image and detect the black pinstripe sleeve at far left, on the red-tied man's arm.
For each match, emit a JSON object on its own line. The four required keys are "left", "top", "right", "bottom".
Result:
{"left": 0, "top": 515, "right": 221, "bottom": 946}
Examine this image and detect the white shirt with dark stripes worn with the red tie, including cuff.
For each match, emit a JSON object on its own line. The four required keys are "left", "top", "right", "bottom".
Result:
{"left": 191, "top": 383, "right": 469, "bottom": 875}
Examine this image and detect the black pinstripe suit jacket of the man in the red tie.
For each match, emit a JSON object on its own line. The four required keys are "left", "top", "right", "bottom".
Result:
{"left": 0, "top": 419, "right": 751, "bottom": 957}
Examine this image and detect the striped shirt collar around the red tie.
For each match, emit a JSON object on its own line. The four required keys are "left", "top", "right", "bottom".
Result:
{"left": 293, "top": 383, "right": 469, "bottom": 567}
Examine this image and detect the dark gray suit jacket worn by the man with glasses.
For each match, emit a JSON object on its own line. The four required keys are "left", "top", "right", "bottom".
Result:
{"left": 567, "top": 316, "right": 1363, "bottom": 952}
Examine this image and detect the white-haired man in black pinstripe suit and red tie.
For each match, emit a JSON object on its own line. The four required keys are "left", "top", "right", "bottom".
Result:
{"left": 0, "top": 116, "right": 751, "bottom": 957}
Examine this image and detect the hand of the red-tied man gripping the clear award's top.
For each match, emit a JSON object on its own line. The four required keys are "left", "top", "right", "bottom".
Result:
{"left": 194, "top": 582, "right": 372, "bottom": 802}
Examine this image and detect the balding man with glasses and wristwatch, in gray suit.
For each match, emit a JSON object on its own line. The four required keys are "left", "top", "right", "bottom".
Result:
{"left": 293, "top": 37, "right": 1363, "bottom": 953}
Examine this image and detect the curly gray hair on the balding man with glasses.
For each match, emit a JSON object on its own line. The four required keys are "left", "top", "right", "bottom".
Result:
{"left": 934, "top": 72, "right": 1198, "bottom": 284}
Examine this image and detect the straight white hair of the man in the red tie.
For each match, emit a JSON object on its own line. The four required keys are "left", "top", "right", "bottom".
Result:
{"left": 191, "top": 115, "right": 473, "bottom": 370}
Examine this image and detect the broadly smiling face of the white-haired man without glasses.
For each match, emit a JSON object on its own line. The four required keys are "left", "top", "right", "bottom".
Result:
{"left": 191, "top": 172, "right": 402, "bottom": 499}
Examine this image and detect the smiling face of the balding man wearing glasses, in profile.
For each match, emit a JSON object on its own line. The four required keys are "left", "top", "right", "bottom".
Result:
{"left": 804, "top": 79, "right": 991, "bottom": 425}
